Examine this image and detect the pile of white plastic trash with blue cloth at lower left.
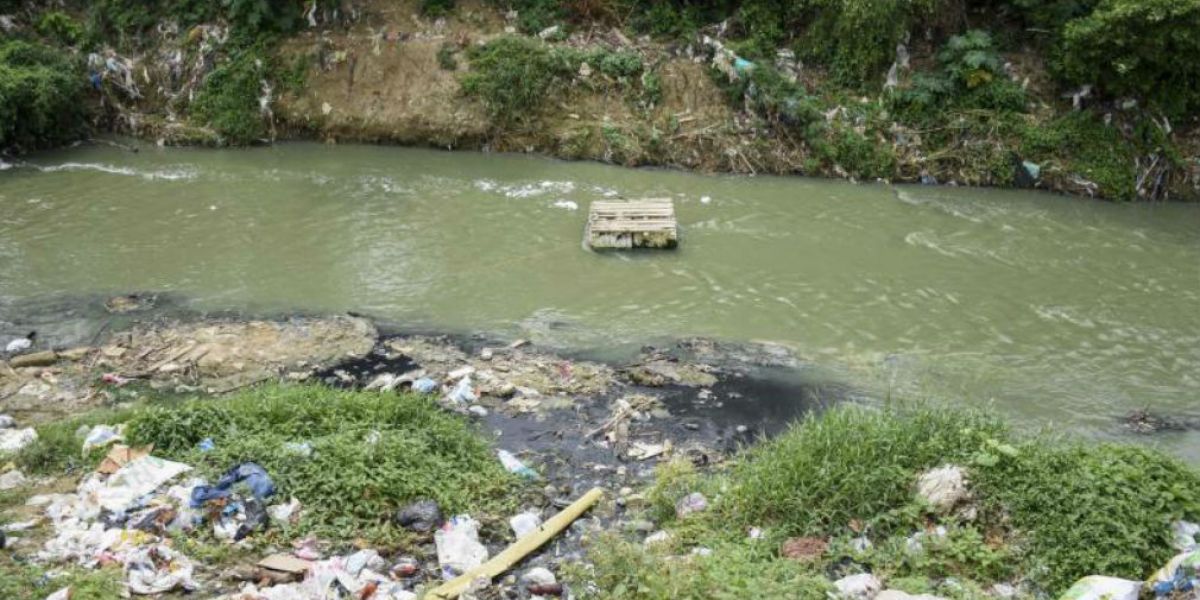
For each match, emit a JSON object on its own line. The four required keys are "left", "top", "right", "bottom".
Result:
{"left": 26, "top": 425, "right": 299, "bottom": 594}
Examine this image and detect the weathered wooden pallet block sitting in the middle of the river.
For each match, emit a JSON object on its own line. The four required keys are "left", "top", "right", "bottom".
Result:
{"left": 584, "top": 198, "right": 679, "bottom": 250}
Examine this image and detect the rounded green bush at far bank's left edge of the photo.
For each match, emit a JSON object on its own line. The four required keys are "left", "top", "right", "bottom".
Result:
{"left": 0, "top": 40, "right": 86, "bottom": 150}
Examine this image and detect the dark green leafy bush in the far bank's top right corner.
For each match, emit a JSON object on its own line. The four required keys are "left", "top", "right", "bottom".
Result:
{"left": 1062, "top": 0, "right": 1200, "bottom": 115}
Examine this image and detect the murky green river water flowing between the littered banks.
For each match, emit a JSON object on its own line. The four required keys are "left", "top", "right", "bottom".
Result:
{"left": 0, "top": 144, "right": 1200, "bottom": 460}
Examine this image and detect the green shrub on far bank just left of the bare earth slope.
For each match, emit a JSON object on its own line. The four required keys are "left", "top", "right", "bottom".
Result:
{"left": 191, "top": 52, "right": 268, "bottom": 145}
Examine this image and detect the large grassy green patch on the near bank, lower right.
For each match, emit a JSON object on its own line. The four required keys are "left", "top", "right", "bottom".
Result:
{"left": 574, "top": 408, "right": 1200, "bottom": 598}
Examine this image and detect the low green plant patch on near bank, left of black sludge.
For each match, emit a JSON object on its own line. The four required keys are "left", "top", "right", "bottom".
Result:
{"left": 128, "top": 386, "right": 516, "bottom": 539}
